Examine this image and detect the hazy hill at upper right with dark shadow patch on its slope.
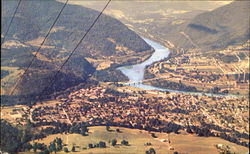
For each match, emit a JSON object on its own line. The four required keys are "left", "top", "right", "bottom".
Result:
{"left": 165, "top": 1, "right": 250, "bottom": 50}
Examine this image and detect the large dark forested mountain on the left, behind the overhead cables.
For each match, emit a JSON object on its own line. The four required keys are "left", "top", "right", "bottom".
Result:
{"left": 1, "top": 0, "right": 152, "bottom": 100}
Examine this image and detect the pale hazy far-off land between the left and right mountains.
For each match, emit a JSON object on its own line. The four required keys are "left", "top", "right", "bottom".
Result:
{"left": 68, "top": 0, "right": 232, "bottom": 46}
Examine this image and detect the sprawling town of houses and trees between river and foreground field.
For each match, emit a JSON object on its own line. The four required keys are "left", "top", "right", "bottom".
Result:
{"left": 2, "top": 86, "right": 249, "bottom": 146}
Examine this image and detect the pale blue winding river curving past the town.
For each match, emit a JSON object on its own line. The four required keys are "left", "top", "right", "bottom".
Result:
{"left": 117, "top": 38, "right": 238, "bottom": 96}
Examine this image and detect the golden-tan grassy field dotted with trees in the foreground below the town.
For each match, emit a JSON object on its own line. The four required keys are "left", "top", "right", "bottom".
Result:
{"left": 27, "top": 126, "right": 248, "bottom": 154}
